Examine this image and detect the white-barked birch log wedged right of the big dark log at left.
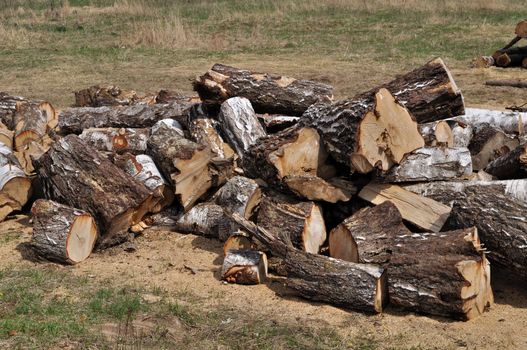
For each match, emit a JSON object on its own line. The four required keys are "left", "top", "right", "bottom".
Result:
{"left": 113, "top": 153, "right": 174, "bottom": 213}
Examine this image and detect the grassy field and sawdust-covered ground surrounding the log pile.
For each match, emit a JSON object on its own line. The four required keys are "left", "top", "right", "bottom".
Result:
{"left": 0, "top": 0, "right": 527, "bottom": 349}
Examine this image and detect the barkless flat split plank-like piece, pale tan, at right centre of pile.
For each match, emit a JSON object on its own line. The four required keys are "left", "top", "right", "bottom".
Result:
{"left": 359, "top": 183, "right": 451, "bottom": 232}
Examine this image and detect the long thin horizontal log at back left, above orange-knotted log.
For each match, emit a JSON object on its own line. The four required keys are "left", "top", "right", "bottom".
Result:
{"left": 58, "top": 103, "right": 187, "bottom": 135}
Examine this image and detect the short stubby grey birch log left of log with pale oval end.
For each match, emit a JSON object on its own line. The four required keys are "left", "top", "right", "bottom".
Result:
{"left": 212, "top": 176, "right": 262, "bottom": 219}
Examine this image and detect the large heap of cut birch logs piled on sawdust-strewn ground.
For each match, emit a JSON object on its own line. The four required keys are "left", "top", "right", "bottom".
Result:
{"left": 0, "top": 58, "right": 527, "bottom": 320}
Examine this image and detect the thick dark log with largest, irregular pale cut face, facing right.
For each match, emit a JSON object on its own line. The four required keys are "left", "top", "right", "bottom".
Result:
{"left": 301, "top": 88, "right": 424, "bottom": 173}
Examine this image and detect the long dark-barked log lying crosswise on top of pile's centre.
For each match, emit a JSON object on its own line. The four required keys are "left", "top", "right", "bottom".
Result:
{"left": 194, "top": 64, "right": 333, "bottom": 115}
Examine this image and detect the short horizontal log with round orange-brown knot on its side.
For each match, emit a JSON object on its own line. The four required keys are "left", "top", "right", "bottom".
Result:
{"left": 79, "top": 128, "right": 150, "bottom": 154}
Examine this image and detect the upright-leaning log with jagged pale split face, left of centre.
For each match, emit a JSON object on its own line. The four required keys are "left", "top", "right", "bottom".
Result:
{"left": 148, "top": 121, "right": 211, "bottom": 211}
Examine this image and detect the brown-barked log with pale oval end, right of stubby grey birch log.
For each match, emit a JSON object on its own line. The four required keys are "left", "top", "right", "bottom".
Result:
{"left": 257, "top": 196, "right": 326, "bottom": 254}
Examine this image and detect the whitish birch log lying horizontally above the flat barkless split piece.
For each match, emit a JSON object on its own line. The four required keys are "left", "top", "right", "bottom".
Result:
{"left": 379, "top": 147, "right": 472, "bottom": 182}
